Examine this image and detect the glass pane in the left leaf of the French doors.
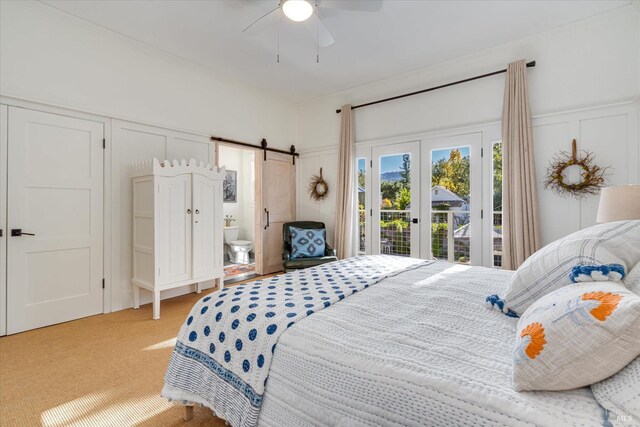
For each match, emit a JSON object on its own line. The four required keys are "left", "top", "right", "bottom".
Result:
{"left": 378, "top": 153, "right": 411, "bottom": 256}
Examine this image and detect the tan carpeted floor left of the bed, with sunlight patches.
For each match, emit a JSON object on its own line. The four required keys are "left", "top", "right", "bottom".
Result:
{"left": 0, "top": 276, "right": 276, "bottom": 427}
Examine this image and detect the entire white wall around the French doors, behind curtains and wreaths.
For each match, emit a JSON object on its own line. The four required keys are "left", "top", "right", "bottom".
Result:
{"left": 297, "top": 6, "right": 640, "bottom": 251}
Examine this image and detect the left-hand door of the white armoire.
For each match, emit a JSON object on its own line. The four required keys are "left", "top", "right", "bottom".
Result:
{"left": 154, "top": 174, "right": 193, "bottom": 287}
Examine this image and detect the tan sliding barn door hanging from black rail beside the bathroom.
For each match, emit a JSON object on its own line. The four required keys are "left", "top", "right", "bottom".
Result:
{"left": 256, "top": 152, "right": 296, "bottom": 274}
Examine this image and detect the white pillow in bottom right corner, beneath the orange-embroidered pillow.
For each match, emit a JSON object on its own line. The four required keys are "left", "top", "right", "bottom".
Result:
{"left": 591, "top": 356, "right": 640, "bottom": 423}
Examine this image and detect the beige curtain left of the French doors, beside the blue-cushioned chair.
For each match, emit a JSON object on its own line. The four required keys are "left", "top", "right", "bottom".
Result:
{"left": 335, "top": 105, "right": 355, "bottom": 259}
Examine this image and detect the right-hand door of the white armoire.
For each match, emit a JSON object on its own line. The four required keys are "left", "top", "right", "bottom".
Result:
{"left": 192, "top": 174, "right": 223, "bottom": 279}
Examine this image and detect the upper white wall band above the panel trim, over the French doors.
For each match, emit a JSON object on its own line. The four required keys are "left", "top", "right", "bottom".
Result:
{"left": 296, "top": 6, "right": 640, "bottom": 152}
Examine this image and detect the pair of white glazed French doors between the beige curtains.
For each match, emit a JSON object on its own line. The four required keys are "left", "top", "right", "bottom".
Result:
{"left": 356, "top": 132, "right": 492, "bottom": 265}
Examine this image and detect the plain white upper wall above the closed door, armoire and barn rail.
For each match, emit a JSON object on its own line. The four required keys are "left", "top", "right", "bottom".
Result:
{"left": 0, "top": 1, "right": 296, "bottom": 148}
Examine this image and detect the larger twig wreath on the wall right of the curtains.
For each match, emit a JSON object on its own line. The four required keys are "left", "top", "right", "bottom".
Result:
{"left": 544, "top": 139, "right": 607, "bottom": 197}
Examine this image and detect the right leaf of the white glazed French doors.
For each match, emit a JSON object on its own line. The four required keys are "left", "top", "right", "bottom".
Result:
{"left": 421, "top": 132, "right": 482, "bottom": 265}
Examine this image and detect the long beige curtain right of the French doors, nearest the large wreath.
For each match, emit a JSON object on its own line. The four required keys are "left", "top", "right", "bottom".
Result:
{"left": 502, "top": 60, "right": 541, "bottom": 270}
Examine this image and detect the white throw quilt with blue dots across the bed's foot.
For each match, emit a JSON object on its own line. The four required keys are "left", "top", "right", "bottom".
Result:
{"left": 162, "top": 255, "right": 425, "bottom": 426}
